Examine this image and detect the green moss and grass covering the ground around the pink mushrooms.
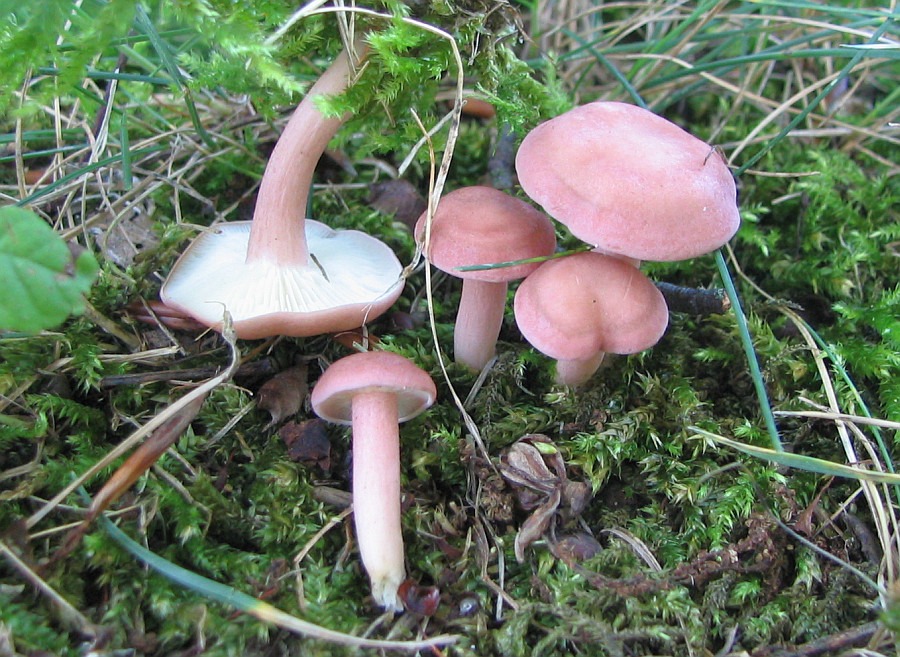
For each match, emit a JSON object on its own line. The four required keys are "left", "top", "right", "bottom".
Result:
{"left": 0, "top": 0, "right": 900, "bottom": 657}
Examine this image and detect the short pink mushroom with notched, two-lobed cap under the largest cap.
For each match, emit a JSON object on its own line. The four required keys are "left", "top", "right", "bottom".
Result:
{"left": 513, "top": 252, "right": 669, "bottom": 385}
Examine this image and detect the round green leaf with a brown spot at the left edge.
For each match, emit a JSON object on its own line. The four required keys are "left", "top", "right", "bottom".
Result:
{"left": 0, "top": 207, "right": 97, "bottom": 333}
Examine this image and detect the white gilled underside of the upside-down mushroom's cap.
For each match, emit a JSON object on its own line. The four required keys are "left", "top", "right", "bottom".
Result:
{"left": 161, "top": 220, "right": 403, "bottom": 325}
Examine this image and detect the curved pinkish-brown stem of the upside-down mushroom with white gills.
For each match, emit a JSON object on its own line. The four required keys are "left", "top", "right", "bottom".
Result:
{"left": 247, "top": 44, "right": 366, "bottom": 267}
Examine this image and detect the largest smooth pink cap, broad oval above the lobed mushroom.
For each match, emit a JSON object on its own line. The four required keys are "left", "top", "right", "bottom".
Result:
{"left": 516, "top": 101, "right": 740, "bottom": 262}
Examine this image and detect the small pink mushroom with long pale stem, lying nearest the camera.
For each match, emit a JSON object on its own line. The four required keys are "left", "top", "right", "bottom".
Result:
{"left": 310, "top": 351, "right": 437, "bottom": 611}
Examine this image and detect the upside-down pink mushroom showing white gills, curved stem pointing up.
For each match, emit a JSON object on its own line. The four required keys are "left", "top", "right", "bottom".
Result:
{"left": 160, "top": 43, "right": 403, "bottom": 338}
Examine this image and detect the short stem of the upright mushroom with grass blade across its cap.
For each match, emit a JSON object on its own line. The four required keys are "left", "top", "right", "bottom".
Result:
{"left": 453, "top": 278, "right": 508, "bottom": 370}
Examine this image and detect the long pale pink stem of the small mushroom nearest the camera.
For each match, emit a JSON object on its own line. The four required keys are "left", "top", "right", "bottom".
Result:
{"left": 352, "top": 390, "right": 406, "bottom": 611}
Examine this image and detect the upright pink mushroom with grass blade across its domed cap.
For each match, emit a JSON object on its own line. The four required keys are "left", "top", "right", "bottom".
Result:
{"left": 416, "top": 186, "right": 556, "bottom": 370}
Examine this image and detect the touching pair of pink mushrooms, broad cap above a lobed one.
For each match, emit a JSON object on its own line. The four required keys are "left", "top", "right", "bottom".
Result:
{"left": 506, "top": 101, "right": 740, "bottom": 385}
